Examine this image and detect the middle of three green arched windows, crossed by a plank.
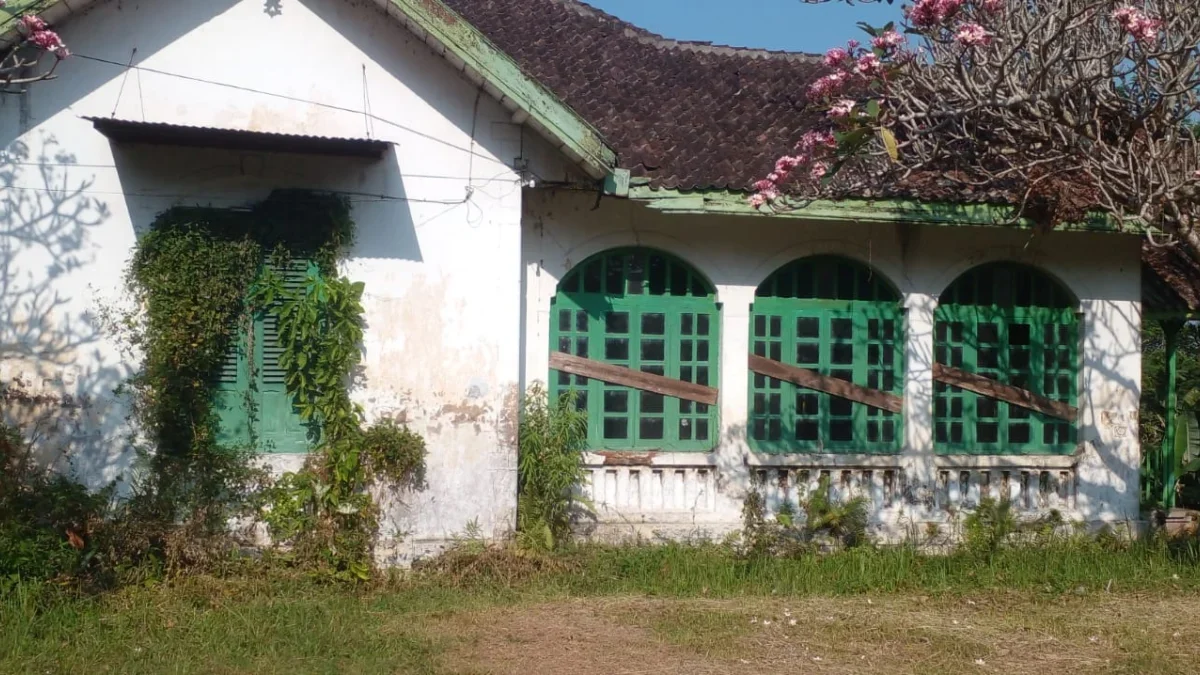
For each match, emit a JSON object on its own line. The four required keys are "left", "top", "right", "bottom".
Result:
{"left": 749, "top": 256, "right": 904, "bottom": 453}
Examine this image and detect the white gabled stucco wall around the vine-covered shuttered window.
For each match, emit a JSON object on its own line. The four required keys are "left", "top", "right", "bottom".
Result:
{"left": 0, "top": 0, "right": 578, "bottom": 561}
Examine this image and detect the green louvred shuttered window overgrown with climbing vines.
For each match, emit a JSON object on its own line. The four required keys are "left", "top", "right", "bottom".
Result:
{"left": 214, "top": 259, "right": 320, "bottom": 454}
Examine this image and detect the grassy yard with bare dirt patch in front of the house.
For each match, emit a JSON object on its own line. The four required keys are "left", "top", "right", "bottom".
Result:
{"left": 0, "top": 540, "right": 1200, "bottom": 675}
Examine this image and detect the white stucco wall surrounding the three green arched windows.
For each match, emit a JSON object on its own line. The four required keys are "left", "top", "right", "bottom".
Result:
{"left": 522, "top": 191, "right": 1141, "bottom": 537}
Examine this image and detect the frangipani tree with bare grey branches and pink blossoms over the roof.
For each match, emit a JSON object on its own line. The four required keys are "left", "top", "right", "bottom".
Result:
{"left": 751, "top": 0, "right": 1200, "bottom": 261}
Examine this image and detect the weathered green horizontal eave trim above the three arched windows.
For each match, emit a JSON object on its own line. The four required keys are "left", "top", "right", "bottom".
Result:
{"left": 629, "top": 184, "right": 1144, "bottom": 234}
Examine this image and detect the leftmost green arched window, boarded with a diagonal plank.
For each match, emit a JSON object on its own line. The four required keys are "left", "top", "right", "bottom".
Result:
{"left": 550, "top": 249, "right": 720, "bottom": 450}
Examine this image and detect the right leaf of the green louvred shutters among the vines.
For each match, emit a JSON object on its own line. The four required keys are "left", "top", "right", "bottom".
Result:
{"left": 254, "top": 261, "right": 319, "bottom": 453}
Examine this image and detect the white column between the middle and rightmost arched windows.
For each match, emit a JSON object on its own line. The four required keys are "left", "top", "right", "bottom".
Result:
{"left": 901, "top": 293, "right": 937, "bottom": 506}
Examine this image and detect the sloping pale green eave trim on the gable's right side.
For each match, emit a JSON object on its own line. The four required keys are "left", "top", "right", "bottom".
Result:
{"left": 390, "top": 0, "right": 617, "bottom": 179}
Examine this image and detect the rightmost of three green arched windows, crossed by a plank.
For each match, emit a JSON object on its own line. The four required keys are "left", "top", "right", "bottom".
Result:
{"left": 934, "top": 263, "right": 1079, "bottom": 454}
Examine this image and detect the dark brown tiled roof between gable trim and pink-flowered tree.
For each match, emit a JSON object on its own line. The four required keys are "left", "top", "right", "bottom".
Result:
{"left": 444, "top": 0, "right": 822, "bottom": 190}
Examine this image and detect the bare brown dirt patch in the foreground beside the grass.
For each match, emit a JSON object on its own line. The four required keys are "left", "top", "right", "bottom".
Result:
{"left": 426, "top": 595, "right": 1200, "bottom": 675}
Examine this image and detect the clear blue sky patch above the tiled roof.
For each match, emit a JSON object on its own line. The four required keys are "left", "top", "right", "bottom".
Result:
{"left": 584, "top": 0, "right": 900, "bottom": 52}
